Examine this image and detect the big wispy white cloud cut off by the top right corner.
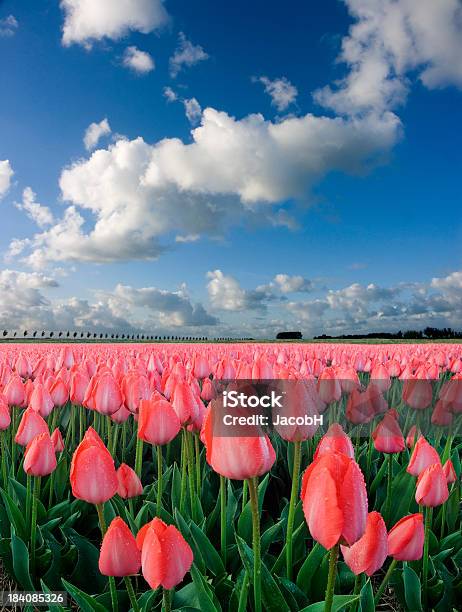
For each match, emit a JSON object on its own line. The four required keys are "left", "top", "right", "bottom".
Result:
{"left": 315, "top": 0, "right": 462, "bottom": 114}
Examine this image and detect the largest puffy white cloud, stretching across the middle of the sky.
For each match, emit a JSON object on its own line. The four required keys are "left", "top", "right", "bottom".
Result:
{"left": 10, "top": 108, "right": 400, "bottom": 265}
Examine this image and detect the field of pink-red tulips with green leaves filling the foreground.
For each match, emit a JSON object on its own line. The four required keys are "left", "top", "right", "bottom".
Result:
{"left": 0, "top": 343, "right": 462, "bottom": 612}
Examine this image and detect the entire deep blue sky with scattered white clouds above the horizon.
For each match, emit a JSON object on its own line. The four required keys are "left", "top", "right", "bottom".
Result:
{"left": 0, "top": 0, "right": 462, "bottom": 337}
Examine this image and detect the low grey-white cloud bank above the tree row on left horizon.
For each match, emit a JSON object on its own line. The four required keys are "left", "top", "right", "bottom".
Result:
{"left": 0, "top": 270, "right": 218, "bottom": 333}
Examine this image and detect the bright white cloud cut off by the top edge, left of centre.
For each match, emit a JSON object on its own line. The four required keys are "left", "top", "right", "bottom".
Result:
{"left": 60, "top": 0, "right": 168, "bottom": 48}
